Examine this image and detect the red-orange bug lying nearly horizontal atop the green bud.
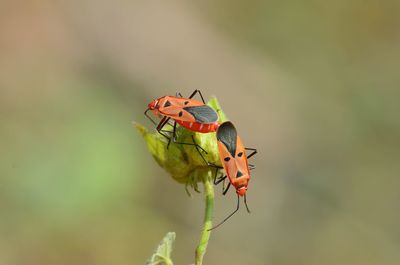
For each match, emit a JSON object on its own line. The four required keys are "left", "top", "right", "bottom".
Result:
{"left": 144, "top": 89, "right": 219, "bottom": 148}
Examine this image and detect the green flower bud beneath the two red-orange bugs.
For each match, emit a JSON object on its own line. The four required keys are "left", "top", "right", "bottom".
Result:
{"left": 135, "top": 97, "right": 226, "bottom": 191}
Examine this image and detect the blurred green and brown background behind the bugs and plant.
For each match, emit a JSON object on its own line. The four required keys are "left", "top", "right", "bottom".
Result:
{"left": 0, "top": 0, "right": 400, "bottom": 265}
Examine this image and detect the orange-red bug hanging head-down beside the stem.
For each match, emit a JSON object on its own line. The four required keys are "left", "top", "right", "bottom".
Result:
{"left": 210, "top": 121, "right": 257, "bottom": 230}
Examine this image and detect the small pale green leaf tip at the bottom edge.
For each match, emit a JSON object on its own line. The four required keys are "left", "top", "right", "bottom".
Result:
{"left": 146, "top": 232, "right": 176, "bottom": 265}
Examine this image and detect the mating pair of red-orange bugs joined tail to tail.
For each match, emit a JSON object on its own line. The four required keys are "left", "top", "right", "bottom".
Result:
{"left": 144, "top": 90, "right": 257, "bottom": 229}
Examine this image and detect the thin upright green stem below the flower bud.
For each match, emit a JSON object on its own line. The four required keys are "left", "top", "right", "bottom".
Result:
{"left": 196, "top": 176, "right": 214, "bottom": 265}
